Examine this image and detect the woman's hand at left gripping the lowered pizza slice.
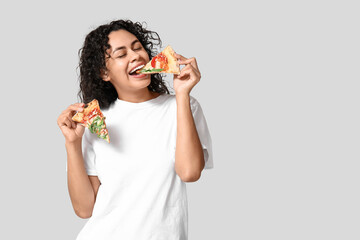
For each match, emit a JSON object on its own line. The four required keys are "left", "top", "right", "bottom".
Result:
{"left": 57, "top": 103, "right": 85, "bottom": 143}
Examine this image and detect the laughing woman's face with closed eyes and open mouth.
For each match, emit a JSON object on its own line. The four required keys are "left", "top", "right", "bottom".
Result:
{"left": 103, "top": 30, "right": 150, "bottom": 91}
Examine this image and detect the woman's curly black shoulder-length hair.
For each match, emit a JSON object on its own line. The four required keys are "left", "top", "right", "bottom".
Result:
{"left": 78, "top": 20, "right": 170, "bottom": 108}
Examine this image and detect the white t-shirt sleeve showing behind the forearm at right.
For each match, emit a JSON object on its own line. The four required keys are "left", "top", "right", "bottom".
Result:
{"left": 190, "top": 96, "right": 214, "bottom": 169}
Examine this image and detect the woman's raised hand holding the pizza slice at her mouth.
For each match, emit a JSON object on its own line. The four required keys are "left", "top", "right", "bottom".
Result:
{"left": 174, "top": 53, "right": 201, "bottom": 95}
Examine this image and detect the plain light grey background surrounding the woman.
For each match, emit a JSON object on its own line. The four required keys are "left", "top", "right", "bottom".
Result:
{"left": 0, "top": 0, "right": 360, "bottom": 240}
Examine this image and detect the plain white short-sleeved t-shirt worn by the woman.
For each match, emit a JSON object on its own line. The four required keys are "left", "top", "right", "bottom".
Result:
{"left": 67, "top": 94, "right": 213, "bottom": 240}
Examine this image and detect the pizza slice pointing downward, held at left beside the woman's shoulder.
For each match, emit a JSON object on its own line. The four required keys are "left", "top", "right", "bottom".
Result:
{"left": 72, "top": 99, "right": 110, "bottom": 143}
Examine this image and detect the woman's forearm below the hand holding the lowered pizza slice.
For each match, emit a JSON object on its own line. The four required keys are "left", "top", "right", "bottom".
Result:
{"left": 65, "top": 142, "right": 95, "bottom": 218}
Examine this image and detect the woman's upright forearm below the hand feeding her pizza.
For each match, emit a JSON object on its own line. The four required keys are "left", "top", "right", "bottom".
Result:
{"left": 175, "top": 94, "right": 205, "bottom": 182}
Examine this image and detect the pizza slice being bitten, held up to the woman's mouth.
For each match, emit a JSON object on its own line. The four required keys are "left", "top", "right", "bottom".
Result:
{"left": 136, "top": 46, "right": 180, "bottom": 74}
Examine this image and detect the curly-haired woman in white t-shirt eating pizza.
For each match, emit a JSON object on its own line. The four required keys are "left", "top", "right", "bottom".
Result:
{"left": 58, "top": 20, "right": 213, "bottom": 240}
